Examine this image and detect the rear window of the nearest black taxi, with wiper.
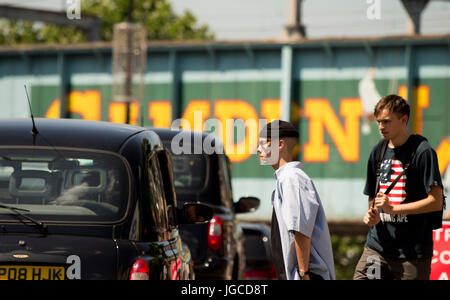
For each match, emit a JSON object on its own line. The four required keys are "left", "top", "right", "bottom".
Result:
{"left": 0, "top": 148, "right": 129, "bottom": 222}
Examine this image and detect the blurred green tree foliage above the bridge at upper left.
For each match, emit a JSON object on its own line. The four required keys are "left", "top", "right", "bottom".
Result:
{"left": 0, "top": 0, "right": 214, "bottom": 45}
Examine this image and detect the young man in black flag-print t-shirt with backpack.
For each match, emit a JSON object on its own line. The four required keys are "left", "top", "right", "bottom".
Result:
{"left": 354, "top": 95, "right": 444, "bottom": 279}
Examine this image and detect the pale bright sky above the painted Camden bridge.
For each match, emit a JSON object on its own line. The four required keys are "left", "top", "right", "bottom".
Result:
{"left": 0, "top": 0, "right": 450, "bottom": 40}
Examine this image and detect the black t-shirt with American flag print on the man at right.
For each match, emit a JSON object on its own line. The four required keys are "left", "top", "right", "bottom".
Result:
{"left": 364, "top": 135, "right": 442, "bottom": 259}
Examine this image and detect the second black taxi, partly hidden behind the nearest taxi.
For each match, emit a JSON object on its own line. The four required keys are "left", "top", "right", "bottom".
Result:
{"left": 153, "top": 128, "right": 259, "bottom": 279}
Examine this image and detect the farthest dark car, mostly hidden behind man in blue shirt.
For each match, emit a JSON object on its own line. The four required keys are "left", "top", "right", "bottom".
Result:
{"left": 241, "top": 223, "right": 277, "bottom": 280}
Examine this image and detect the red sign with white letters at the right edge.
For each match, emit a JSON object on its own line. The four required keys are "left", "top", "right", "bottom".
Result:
{"left": 430, "top": 221, "right": 450, "bottom": 280}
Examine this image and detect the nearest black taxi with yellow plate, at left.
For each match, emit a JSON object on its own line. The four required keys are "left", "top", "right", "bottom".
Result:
{"left": 0, "top": 119, "right": 212, "bottom": 280}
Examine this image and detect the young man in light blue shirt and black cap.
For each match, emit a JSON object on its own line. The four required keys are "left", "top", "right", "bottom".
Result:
{"left": 258, "top": 120, "right": 335, "bottom": 280}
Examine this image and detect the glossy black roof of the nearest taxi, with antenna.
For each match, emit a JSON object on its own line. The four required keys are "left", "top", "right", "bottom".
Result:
{"left": 0, "top": 118, "right": 146, "bottom": 152}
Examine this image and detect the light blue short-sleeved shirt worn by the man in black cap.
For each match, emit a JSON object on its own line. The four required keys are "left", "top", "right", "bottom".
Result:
{"left": 272, "top": 161, "right": 335, "bottom": 280}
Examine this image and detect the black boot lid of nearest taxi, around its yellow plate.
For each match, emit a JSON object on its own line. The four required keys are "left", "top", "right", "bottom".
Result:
{"left": 0, "top": 234, "right": 118, "bottom": 279}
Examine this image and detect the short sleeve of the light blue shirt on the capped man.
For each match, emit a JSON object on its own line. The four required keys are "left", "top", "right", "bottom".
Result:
{"left": 279, "top": 175, "right": 319, "bottom": 238}
